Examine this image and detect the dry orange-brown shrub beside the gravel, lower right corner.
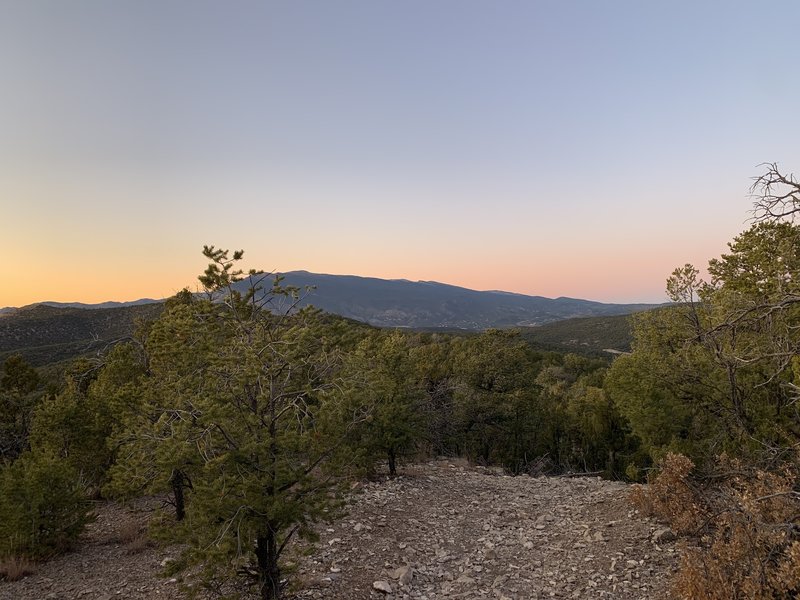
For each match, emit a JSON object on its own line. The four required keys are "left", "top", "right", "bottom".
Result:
{"left": 631, "top": 454, "right": 800, "bottom": 600}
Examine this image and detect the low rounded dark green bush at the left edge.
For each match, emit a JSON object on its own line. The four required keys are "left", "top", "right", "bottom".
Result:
{"left": 0, "top": 453, "right": 90, "bottom": 558}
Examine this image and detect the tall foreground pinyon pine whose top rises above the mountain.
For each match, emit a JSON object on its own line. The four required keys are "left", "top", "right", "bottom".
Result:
{"left": 113, "top": 247, "right": 363, "bottom": 598}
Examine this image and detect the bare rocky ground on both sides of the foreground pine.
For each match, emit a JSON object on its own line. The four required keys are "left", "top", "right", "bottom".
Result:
{"left": 0, "top": 461, "right": 678, "bottom": 600}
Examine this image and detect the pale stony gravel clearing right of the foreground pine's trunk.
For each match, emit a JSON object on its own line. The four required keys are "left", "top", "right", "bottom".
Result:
{"left": 290, "top": 463, "right": 678, "bottom": 600}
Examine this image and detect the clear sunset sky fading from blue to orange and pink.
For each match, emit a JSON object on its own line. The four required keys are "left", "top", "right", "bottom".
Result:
{"left": 0, "top": 0, "right": 800, "bottom": 306}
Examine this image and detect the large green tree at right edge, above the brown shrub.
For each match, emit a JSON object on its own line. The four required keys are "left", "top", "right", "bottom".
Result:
{"left": 606, "top": 223, "right": 800, "bottom": 464}
